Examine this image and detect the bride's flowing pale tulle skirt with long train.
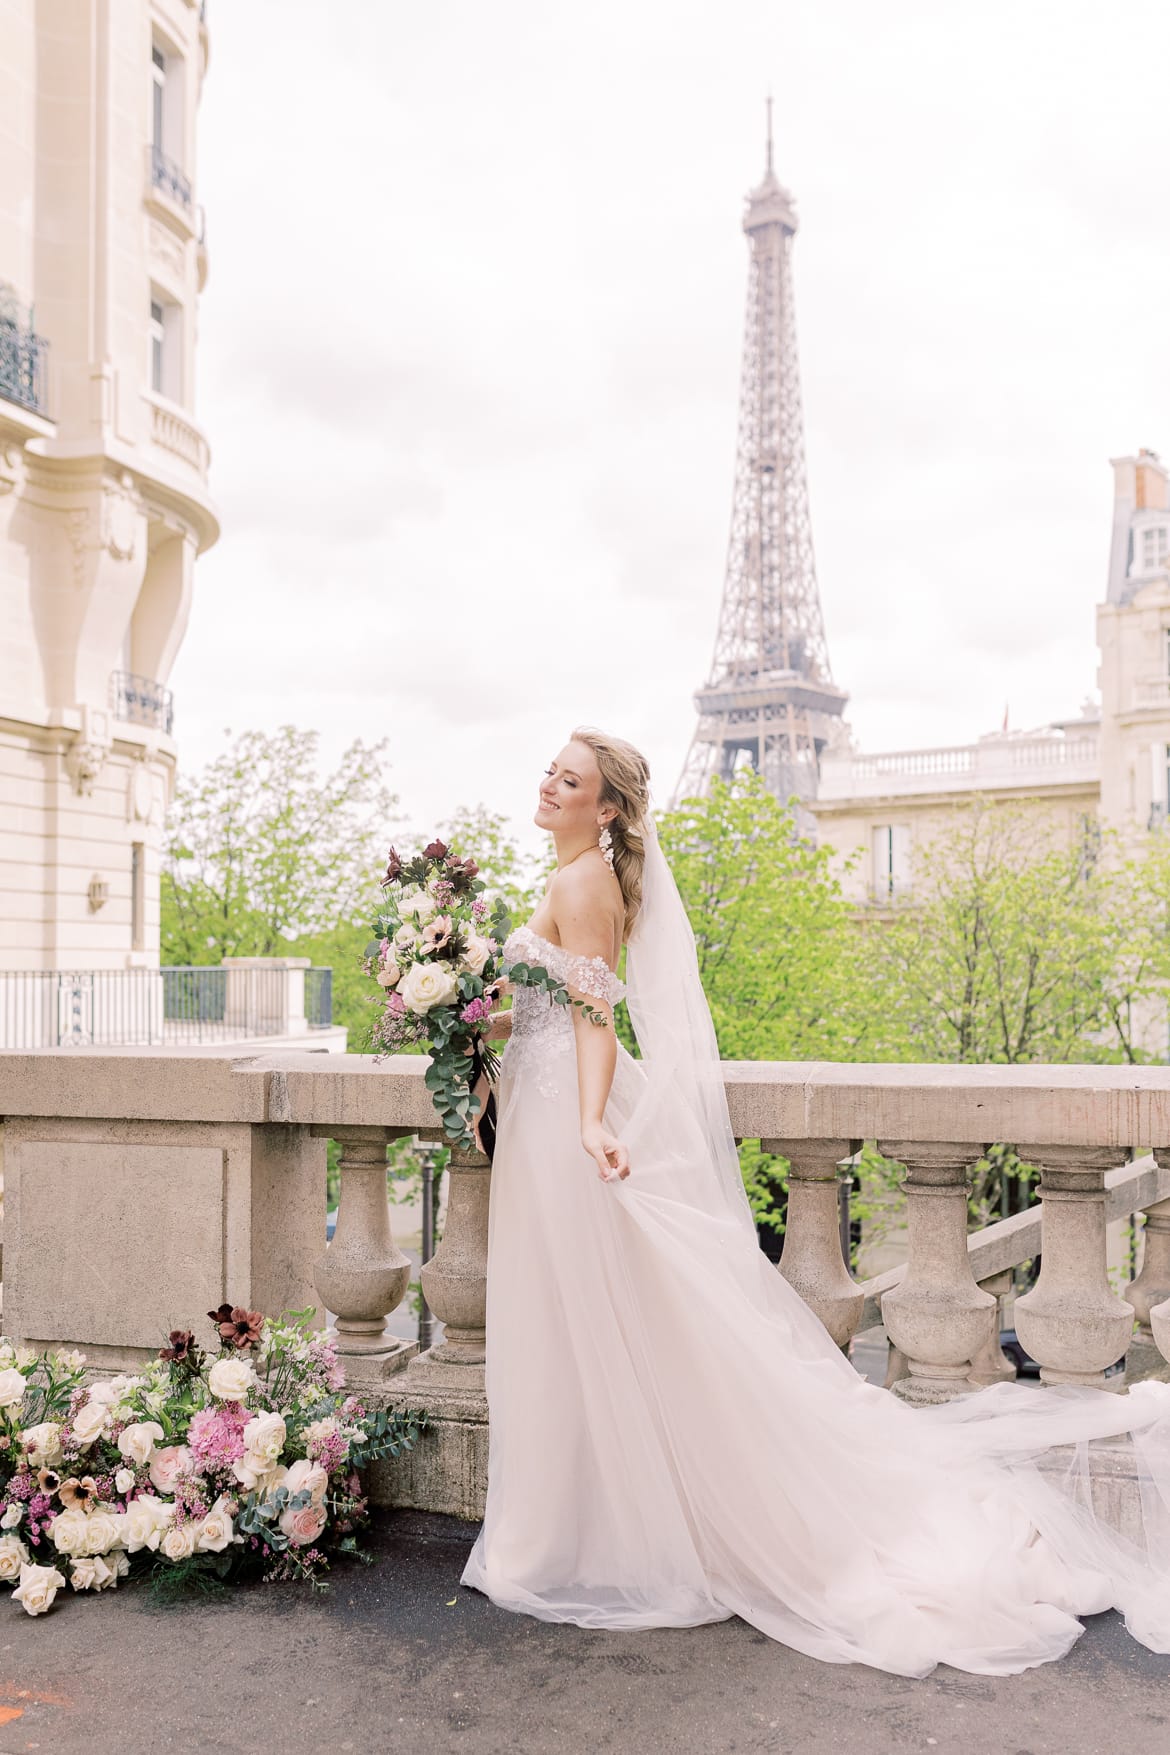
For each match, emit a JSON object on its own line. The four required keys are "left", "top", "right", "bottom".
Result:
{"left": 463, "top": 1051, "right": 1170, "bottom": 1676}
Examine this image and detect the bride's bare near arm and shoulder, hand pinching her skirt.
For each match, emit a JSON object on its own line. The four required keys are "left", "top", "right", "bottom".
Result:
{"left": 553, "top": 870, "right": 630, "bottom": 1181}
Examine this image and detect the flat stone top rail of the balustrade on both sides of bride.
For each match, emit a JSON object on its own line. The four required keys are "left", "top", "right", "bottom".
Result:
{"left": 0, "top": 1049, "right": 1170, "bottom": 1148}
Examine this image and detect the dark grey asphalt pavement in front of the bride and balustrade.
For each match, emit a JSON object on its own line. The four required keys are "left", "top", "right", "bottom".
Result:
{"left": 0, "top": 1513, "right": 1170, "bottom": 1755}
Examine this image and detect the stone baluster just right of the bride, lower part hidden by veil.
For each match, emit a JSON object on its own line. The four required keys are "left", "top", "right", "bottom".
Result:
{"left": 760, "top": 1139, "right": 865, "bottom": 1346}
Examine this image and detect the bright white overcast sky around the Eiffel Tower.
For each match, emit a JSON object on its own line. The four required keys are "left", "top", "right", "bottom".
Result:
{"left": 172, "top": 0, "right": 1170, "bottom": 839}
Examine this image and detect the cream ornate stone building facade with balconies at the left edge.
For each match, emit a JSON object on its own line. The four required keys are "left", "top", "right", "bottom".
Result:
{"left": 0, "top": 0, "right": 218, "bottom": 971}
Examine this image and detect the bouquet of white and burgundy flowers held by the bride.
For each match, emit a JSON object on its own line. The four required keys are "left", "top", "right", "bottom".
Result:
{"left": 363, "top": 841, "right": 607, "bottom": 1148}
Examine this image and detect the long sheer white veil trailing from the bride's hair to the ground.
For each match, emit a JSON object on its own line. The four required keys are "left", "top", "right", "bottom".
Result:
{"left": 603, "top": 823, "right": 1170, "bottom": 1674}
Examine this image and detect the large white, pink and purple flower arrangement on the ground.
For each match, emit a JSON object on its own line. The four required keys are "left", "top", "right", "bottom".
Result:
{"left": 0, "top": 1304, "right": 426, "bottom": 1615}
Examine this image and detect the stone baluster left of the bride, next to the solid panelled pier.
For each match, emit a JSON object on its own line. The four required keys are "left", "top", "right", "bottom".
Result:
{"left": 312, "top": 1127, "right": 417, "bottom": 1381}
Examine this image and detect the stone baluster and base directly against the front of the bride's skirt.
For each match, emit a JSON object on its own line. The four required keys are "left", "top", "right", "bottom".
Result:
{"left": 370, "top": 1151, "right": 491, "bottom": 1518}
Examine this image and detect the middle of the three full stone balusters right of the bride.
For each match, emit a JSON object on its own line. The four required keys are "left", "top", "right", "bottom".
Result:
{"left": 879, "top": 1141, "right": 996, "bottom": 1404}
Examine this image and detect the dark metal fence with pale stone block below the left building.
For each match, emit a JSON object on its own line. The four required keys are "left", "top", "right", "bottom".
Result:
{"left": 0, "top": 965, "right": 333, "bottom": 1049}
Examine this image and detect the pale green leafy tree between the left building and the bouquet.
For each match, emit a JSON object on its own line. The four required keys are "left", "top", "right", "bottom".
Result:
{"left": 161, "top": 725, "right": 398, "bottom": 963}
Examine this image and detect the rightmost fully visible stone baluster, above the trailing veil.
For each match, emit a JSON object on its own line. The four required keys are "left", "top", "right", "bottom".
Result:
{"left": 1016, "top": 1144, "right": 1133, "bottom": 1390}
